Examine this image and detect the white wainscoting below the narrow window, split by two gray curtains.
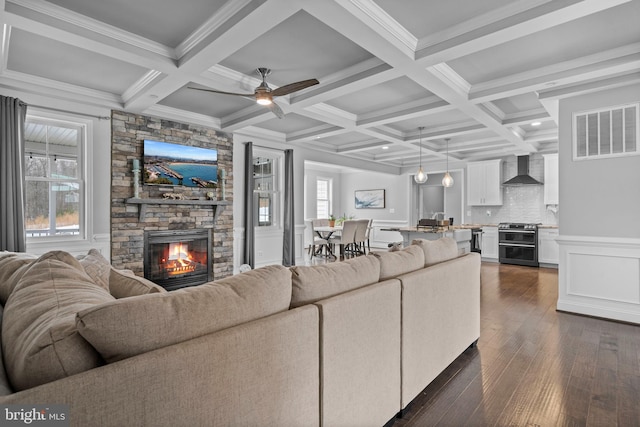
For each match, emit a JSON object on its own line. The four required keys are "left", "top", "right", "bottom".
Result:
{"left": 233, "top": 224, "right": 305, "bottom": 274}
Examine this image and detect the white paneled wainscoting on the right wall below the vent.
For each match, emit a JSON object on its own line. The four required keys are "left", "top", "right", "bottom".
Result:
{"left": 557, "top": 235, "right": 640, "bottom": 324}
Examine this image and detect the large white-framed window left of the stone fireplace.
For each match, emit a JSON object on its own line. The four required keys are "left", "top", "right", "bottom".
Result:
{"left": 25, "top": 116, "right": 86, "bottom": 239}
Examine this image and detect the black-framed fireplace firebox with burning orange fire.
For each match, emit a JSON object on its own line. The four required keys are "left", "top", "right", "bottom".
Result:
{"left": 144, "top": 230, "right": 213, "bottom": 291}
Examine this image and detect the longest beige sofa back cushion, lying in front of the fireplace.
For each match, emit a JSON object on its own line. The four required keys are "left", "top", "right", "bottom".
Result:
{"left": 77, "top": 265, "right": 291, "bottom": 362}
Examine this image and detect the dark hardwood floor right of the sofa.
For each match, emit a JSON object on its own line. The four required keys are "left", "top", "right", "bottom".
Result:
{"left": 390, "top": 263, "right": 640, "bottom": 427}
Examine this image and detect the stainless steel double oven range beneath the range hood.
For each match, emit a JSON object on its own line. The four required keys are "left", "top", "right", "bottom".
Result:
{"left": 498, "top": 223, "right": 538, "bottom": 267}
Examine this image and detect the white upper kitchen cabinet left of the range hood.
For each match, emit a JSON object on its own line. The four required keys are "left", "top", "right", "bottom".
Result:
{"left": 467, "top": 159, "right": 502, "bottom": 206}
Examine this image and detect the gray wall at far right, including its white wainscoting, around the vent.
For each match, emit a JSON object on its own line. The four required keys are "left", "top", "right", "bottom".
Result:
{"left": 557, "top": 85, "right": 640, "bottom": 323}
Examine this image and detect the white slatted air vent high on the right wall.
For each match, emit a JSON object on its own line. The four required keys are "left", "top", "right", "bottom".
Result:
{"left": 573, "top": 104, "right": 640, "bottom": 160}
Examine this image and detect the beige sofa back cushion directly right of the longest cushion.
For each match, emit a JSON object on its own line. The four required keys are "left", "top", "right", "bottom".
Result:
{"left": 291, "top": 255, "right": 380, "bottom": 308}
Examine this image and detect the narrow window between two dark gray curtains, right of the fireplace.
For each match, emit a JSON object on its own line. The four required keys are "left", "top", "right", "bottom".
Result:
{"left": 253, "top": 153, "right": 281, "bottom": 227}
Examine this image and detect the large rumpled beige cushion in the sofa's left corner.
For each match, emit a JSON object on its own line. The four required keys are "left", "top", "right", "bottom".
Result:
{"left": 2, "top": 251, "right": 114, "bottom": 390}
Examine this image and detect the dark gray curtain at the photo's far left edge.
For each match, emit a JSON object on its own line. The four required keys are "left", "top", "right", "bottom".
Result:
{"left": 0, "top": 95, "right": 27, "bottom": 252}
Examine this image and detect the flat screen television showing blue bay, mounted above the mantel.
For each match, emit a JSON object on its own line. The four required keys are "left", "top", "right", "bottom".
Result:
{"left": 143, "top": 139, "right": 218, "bottom": 188}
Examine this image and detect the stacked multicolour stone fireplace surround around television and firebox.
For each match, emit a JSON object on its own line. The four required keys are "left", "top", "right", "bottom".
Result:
{"left": 111, "top": 111, "right": 233, "bottom": 280}
